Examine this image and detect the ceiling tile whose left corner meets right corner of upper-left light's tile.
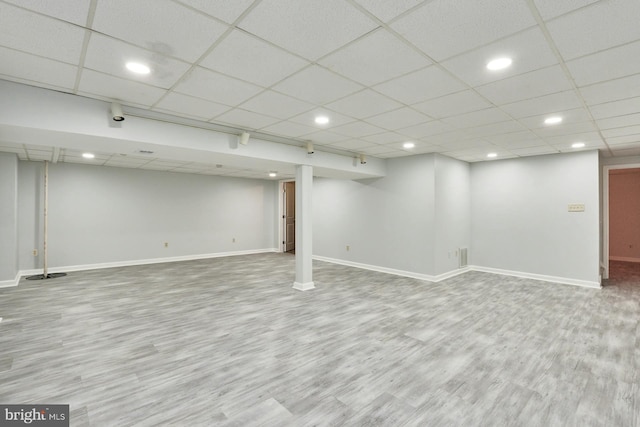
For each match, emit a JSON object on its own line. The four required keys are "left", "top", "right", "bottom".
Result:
{"left": 200, "top": 30, "right": 308, "bottom": 87}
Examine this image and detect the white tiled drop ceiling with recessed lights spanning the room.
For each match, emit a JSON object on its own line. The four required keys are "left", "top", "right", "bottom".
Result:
{"left": 0, "top": 0, "right": 640, "bottom": 177}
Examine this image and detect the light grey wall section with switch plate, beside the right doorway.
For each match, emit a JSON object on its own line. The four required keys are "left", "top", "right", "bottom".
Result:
{"left": 470, "top": 151, "right": 599, "bottom": 285}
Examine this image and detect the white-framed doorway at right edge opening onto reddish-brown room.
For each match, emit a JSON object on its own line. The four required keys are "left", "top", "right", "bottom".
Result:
{"left": 602, "top": 164, "right": 640, "bottom": 281}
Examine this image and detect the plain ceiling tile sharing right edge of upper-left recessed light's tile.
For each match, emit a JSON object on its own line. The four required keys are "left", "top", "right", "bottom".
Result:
{"left": 175, "top": 67, "right": 262, "bottom": 105}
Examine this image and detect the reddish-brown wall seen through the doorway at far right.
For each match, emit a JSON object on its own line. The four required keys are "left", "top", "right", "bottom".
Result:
{"left": 609, "top": 169, "right": 640, "bottom": 262}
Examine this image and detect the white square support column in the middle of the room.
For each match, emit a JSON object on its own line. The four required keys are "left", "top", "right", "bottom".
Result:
{"left": 293, "top": 165, "right": 315, "bottom": 291}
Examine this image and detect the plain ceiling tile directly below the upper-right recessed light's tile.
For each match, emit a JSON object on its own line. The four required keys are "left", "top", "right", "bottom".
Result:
{"left": 476, "top": 65, "right": 572, "bottom": 105}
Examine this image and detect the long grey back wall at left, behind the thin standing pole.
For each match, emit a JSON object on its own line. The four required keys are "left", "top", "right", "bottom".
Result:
{"left": 18, "top": 161, "right": 277, "bottom": 270}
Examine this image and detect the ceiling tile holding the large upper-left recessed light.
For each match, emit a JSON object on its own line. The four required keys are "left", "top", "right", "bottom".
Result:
{"left": 84, "top": 33, "right": 190, "bottom": 89}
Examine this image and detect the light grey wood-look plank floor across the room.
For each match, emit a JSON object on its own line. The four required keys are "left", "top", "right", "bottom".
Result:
{"left": 0, "top": 254, "right": 640, "bottom": 426}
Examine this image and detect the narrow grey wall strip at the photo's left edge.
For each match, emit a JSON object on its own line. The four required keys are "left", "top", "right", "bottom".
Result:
{"left": 0, "top": 153, "right": 18, "bottom": 285}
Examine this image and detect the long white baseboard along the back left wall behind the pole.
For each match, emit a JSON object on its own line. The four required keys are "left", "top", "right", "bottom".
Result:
{"left": 16, "top": 248, "right": 278, "bottom": 284}
